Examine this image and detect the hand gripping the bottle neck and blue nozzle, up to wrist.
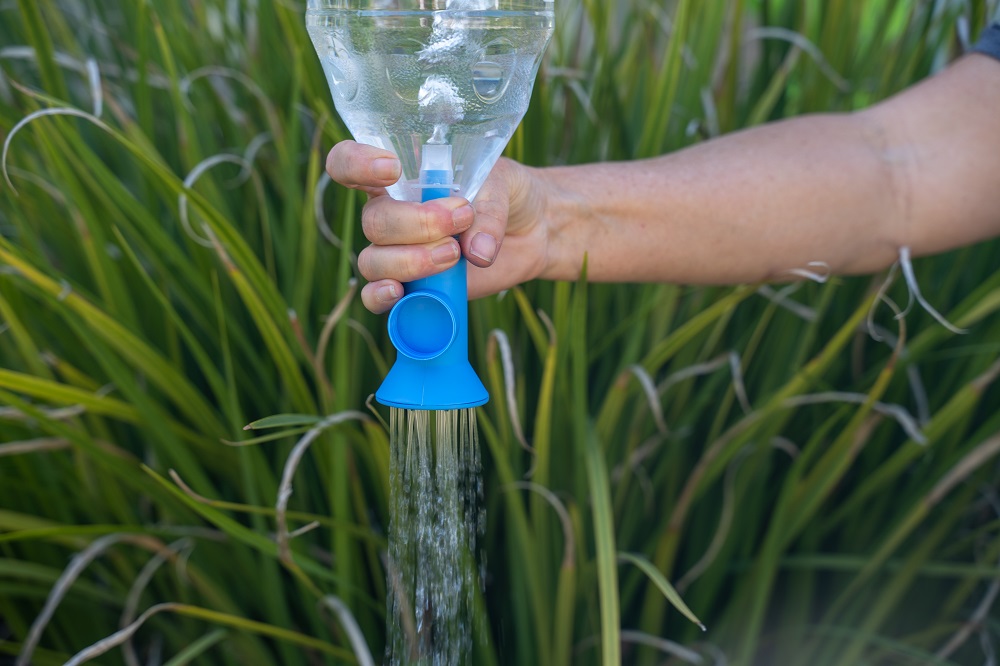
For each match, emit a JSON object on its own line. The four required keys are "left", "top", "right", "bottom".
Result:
{"left": 326, "top": 141, "right": 548, "bottom": 314}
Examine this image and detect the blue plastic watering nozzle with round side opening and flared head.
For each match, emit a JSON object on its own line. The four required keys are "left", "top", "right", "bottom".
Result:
{"left": 375, "top": 144, "right": 489, "bottom": 410}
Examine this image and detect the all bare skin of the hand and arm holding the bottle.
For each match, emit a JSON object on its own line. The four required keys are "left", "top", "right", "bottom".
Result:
{"left": 327, "top": 55, "right": 1000, "bottom": 313}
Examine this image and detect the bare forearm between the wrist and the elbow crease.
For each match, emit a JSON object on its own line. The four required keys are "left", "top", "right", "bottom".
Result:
{"left": 542, "top": 116, "right": 896, "bottom": 284}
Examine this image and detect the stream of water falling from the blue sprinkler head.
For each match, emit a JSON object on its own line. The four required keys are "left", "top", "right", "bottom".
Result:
{"left": 386, "top": 409, "right": 486, "bottom": 666}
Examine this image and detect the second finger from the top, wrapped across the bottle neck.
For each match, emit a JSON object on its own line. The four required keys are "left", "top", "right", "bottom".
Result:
{"left": 361, "top": 197, "right": 476, "bottom": 246}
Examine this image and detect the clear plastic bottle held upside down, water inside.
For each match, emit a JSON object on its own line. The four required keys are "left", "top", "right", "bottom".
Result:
{"left": 306, "top": 0, "right": 554, "bottom": 201}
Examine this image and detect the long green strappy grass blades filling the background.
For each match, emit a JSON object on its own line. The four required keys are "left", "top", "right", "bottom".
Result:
{"left": 0, "top": 0, "right": 1000, "bottom": 666}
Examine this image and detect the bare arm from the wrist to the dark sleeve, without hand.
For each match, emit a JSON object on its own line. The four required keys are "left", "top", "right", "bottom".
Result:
{"left": 539, "top": 55, "right": 1000, "bottom": 284}
